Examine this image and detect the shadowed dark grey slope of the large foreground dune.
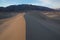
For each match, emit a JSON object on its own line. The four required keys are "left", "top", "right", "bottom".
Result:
{"left": 25, "top": 13, "right": 60, "bottom": 40}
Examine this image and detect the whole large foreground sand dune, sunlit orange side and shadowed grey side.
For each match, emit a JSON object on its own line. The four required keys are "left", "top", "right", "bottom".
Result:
{"left": 0, "top": 11, "right": 60, "bottom": 40}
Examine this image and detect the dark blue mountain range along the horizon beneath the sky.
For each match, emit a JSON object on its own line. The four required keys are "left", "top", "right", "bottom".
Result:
{"left": 0, "top": 4, "right": 55, "bottom": 12}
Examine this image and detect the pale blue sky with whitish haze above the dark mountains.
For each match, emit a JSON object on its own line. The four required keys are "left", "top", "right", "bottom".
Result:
{"left": 0, "top": 0, "right": 60, "bottom": 8}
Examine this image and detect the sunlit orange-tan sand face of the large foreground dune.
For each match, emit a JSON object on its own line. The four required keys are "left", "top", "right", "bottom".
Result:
{"left": 0, "top": 13, "right": 26, "bottom": 40}
